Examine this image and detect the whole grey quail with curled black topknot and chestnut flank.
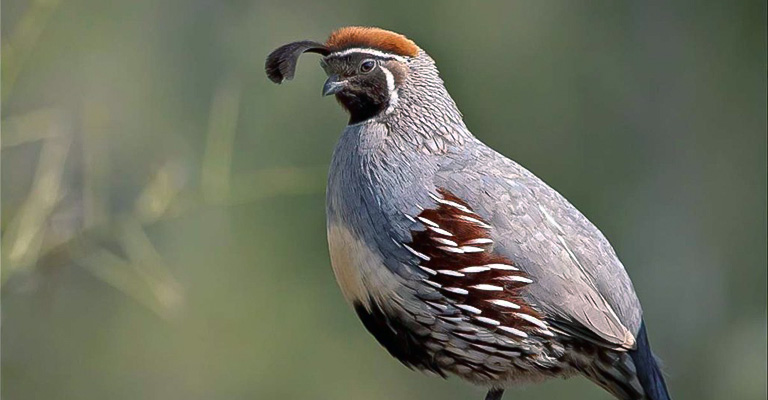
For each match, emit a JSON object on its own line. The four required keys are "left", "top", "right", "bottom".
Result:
{"left": 265, "top": 26, "right": 670, "bottom": 400}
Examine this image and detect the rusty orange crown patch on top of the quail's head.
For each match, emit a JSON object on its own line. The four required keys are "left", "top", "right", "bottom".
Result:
{"left": 325, "top": 26, "right": 419, "bottom": 57}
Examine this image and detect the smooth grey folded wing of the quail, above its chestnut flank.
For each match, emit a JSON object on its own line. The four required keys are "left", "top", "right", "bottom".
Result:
{"left": 435, "top": 149, "right": 642, "bottom": 349}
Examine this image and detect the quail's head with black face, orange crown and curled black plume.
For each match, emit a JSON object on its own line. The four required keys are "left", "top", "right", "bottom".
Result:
{"left": 266, "top": 27, "right": 420, "bottom": 123}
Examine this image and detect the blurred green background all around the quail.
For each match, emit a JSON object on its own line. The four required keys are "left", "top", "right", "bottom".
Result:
{"left": 0, "top": 0, "right": 768, "bottom": 400}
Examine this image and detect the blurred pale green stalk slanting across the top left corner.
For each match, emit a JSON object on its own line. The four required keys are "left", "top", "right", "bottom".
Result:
{"left": 0, "top": 0, "right": 60, "bottom": 103}
